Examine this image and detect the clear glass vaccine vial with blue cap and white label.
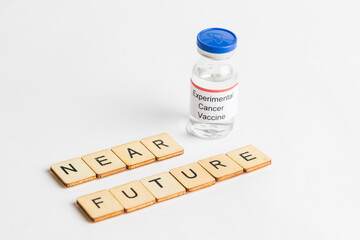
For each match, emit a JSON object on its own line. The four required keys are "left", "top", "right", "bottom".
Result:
{"left": 187, "top": 28, "right": 238, "bottom": 139}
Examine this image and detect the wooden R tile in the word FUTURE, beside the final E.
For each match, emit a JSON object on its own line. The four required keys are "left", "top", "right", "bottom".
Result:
{"left": 198, "top": 154, "right": 243, "bottom": 182}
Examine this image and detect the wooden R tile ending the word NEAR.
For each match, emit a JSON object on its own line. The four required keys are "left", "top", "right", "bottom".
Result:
{"left": 140, "top": 133, "right": 184, "bottom": 161}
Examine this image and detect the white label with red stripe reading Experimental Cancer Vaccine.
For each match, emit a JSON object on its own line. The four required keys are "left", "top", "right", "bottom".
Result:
{"left": 190, "top": 80, "right": 238, "bottom": 123}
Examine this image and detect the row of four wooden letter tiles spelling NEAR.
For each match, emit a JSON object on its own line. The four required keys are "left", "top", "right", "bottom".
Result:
{"left": 50, "top": 133, "right": 184, "bottom": 187}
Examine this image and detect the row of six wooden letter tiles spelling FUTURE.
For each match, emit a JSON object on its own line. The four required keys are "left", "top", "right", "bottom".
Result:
{"left": 77, "top": 145, "right": 271, "bottom": 222}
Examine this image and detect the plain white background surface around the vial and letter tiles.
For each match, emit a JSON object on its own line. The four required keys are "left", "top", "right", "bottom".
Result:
{"left": 0, "top": 0, "right": 360, "bottom": 240}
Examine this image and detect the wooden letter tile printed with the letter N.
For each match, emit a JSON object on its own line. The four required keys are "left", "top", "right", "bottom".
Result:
{"left": 50, "top": 158, "right": 96, "bottom": 187}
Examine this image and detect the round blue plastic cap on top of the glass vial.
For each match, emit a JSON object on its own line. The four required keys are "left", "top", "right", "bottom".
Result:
{"left": 196, "top": 28, "right": 237, "bottom": 54}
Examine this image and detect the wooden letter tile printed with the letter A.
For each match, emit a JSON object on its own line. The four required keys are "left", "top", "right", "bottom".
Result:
{"left": 111, "top": 141, "right": 155, "bottom": 169}
